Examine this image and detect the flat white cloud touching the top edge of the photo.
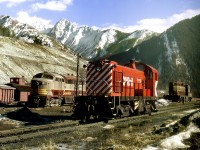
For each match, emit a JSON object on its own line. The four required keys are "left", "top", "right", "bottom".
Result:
{"left": 32, "top": 0, "right": 73, "bottom": 11}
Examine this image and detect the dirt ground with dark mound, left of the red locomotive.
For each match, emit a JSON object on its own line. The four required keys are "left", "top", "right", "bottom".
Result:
{"left": 0, "top": 106, "right": 72, "bottom": 131}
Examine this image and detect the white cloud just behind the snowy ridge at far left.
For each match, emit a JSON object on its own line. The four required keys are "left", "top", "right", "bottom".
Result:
{"left": 16, "top": 11, "right": 53, "bottom": 31}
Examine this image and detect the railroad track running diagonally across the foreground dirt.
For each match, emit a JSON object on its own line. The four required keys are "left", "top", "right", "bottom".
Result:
{"left": 0, "top": 102, "right": 199, "bottom": 145}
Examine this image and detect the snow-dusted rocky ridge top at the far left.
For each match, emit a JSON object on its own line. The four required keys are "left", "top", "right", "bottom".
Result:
{"left": 0, "top": 15, "right": 53, "bottom": 47}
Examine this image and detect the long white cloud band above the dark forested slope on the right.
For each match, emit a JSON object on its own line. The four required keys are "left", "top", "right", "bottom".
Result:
{"left": 104, "top": 9, "right": 200, "bottom": 33}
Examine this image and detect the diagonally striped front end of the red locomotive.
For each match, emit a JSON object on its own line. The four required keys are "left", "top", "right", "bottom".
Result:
{"left": 87, "top": 64, "right": 112, "bottom": 95}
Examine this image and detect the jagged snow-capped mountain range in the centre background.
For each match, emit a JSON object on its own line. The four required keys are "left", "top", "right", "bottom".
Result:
{"left": 48, "top": 19, "right": 155, "bottom": 60}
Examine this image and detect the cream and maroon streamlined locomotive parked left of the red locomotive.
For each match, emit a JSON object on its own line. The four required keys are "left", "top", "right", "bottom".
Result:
{"left": 28, "top": 72, "right": 86, "bottom": 107}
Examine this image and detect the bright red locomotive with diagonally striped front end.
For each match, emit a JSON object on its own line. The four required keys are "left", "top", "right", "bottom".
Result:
{"left": 74, "top": 60, "right": 158, "bottom": 119}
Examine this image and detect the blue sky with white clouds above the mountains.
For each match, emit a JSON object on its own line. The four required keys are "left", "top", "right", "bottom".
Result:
{"left": 0, "top": 0, "right": 200, "bottom": 32}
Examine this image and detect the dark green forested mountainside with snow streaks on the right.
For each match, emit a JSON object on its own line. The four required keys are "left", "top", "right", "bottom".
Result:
{"left": 109, "top": 15, "right": 200, "bottom": 96}
